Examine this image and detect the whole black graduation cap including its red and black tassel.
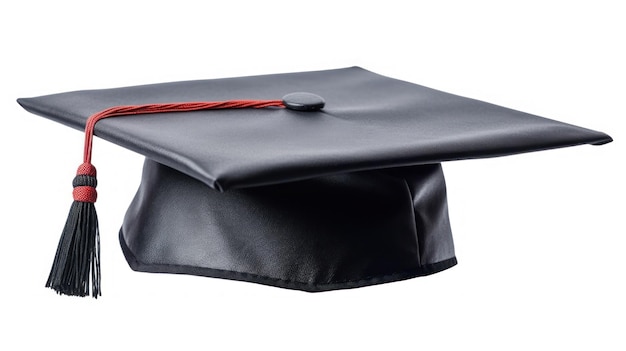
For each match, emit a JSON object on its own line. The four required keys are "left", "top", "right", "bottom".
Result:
{"left": 18, "top": 67, "right": 612, "bottom": 296}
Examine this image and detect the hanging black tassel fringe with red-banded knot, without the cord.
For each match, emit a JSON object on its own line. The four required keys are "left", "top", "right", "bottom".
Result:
{"left": 46, "top": 163, "right": 101, "bottom": 298}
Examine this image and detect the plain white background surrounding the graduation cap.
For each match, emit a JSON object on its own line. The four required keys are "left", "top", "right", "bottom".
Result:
{"left": 0, "top": 0, "right": 626, "bottom": 350}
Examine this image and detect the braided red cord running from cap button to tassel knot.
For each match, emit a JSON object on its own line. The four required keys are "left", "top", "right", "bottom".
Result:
{"left": 83, "top": 100, "right": 285, "bottom": 164}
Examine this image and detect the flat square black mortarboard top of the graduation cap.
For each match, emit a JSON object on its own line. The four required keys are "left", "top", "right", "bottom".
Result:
{"left": 18, "top": 67, "right": 611, "bottom": 190}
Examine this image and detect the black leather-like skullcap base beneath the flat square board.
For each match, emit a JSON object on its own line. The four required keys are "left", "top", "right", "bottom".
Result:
{"left": 120, "top": 159, "right": 456, "bottom": 291}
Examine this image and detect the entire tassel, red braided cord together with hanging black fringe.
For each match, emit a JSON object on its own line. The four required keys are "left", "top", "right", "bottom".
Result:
{"left": 46, "top": 100, "right": 285, "bottom": 298}
